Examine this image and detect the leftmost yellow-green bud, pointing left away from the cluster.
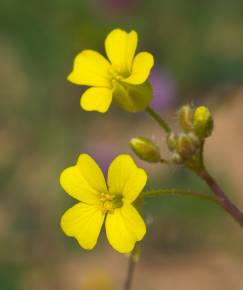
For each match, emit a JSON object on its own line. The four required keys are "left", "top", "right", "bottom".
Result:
{"left": 130, "top": 137, "right": 161, "bottom": 163}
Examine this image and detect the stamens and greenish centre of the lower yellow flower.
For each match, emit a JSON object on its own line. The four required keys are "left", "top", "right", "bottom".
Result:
{"left": 100, "top": 193, "right": 123, "bottom": 213}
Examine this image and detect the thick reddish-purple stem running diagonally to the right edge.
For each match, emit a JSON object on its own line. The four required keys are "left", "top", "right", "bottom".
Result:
{"left": 196, "top": 169, "right": 243, "bottom": 227}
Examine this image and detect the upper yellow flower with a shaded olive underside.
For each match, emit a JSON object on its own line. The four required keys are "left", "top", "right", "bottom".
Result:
{"left": 68, "top": 29, "right": 154, "bottom": 113}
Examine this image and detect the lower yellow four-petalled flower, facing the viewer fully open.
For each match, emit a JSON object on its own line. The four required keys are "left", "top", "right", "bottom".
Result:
{"left": 60, "top": 154, "right": 147, "bottom": 253}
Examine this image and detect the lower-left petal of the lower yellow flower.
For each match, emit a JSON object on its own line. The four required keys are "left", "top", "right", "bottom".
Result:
{"left": 61, "top": 203, "right": 105, "bottom": 250}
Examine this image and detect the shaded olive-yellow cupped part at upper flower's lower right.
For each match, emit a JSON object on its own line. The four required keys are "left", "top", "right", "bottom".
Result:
{"left": 113, "top": 81, "right": 153, "bottom": 112}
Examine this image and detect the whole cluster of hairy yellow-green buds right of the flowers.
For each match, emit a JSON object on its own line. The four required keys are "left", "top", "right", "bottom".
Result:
{"left": 130, "top": 105, "right": 213, "bottom": 165}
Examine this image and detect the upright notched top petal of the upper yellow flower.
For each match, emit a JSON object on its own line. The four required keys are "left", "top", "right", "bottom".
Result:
{"left": 105, "top": 29, "right": 138, "bottom": 75}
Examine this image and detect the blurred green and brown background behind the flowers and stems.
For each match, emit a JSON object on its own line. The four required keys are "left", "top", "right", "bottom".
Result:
{"left": 0, "top": 0, "right": 243, "bottom": 290}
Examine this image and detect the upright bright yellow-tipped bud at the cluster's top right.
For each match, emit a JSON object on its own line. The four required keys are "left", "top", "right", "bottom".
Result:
{"left": 193, "top": 106, "right": 213, "bottom": 139}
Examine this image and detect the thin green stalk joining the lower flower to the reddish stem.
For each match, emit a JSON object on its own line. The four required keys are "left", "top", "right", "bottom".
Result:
{"left": 142, "top": 189, "right": 220, "bottom": 205}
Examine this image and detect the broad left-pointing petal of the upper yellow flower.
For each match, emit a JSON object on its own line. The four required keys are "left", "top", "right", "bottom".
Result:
{"left": 68, "top": 50, "right": 111, "bottom": 87}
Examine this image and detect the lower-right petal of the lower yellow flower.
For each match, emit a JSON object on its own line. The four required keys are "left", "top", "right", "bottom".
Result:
{"left": 105, "top": 204, "right": 146, "bottom": 253}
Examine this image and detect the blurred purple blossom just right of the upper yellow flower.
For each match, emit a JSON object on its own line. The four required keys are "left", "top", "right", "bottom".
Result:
{"left": 149, "top": 67, "right": 176, "bottom": 111}
